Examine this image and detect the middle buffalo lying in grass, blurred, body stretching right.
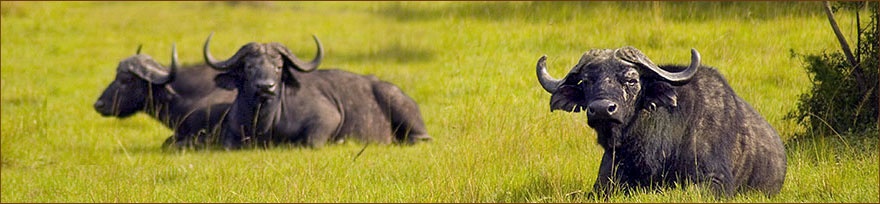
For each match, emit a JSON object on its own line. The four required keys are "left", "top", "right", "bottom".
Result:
{"left": 204, "top": 33, "right": 431, "bottom": 148}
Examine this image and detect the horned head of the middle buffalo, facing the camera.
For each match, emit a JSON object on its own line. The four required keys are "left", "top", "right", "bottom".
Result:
{"left": 204, "top": 33, "right": 324, "bottom": 100}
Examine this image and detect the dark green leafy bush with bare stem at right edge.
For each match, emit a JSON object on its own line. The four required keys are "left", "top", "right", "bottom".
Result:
{"left": 788, "top": 2, "right": 880, "bottom": 136}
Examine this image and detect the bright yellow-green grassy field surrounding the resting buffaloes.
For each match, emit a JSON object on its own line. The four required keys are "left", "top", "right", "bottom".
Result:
{"left": 0, "top": 2, "right": 880, "bottom": 202}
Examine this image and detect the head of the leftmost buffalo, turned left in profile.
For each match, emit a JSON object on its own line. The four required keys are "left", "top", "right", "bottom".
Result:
{"left": 94, "top": 45, "right": 179, "bottom": 117}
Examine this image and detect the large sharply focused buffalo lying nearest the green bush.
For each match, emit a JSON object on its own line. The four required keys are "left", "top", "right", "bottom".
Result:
{"left": 537, "top": 47, "right": 786, "bottom": 197}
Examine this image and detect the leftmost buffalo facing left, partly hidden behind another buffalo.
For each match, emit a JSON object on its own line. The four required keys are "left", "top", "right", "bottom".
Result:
{"left": 94, "top": 44, "right": 235, "bottom": 147}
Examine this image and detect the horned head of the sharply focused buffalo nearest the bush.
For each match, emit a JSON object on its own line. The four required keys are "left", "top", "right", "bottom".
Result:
{"left": 536, "top": 47, "right": 700, "bottom": 128}
